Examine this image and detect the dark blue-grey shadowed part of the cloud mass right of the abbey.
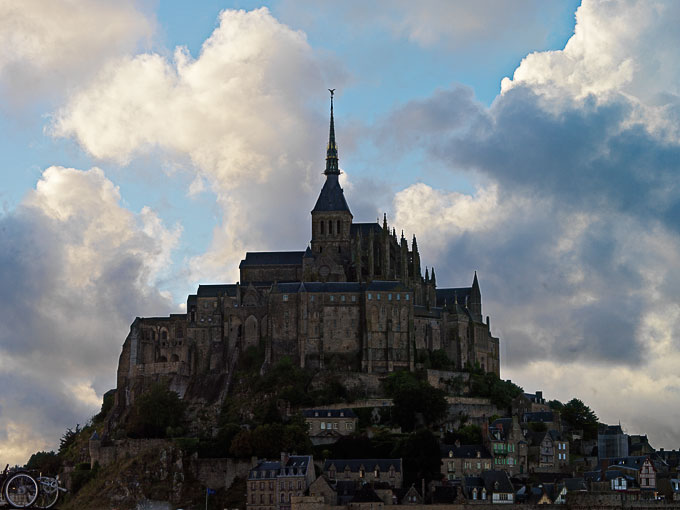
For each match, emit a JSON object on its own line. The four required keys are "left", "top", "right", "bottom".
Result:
{"left": 382, "top": 78, "right": 680, "bottom": 366}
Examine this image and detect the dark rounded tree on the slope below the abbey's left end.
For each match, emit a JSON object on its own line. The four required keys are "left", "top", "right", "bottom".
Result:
{"left": 126, "top": 383, "right": 184, "bottom": 438}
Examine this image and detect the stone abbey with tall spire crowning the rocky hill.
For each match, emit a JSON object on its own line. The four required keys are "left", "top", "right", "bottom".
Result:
{"left": 118, "top": 97, "right": 500, "bottom": 402}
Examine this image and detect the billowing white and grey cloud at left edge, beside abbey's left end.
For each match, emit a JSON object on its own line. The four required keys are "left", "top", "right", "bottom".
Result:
{"left": 0, "top": 167, "right": 180, "bottom": 463}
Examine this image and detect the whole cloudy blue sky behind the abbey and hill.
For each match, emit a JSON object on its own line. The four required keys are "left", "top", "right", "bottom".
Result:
{"left": 0, "top": 0, "right": 680, "bottom": 464}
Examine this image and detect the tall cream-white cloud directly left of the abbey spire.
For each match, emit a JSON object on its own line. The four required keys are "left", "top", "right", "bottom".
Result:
{"left": 52, "top": 8, "right": 344, "bottom": 280}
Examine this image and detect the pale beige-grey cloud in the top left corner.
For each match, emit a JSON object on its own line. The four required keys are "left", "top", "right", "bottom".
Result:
{"left": 0, "top": 0, "right": 153, "bottom": 107}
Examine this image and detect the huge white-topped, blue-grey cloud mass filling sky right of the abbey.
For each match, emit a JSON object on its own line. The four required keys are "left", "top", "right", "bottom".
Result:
{"left": 376, "top": 0, "right": 680, "bottom": 446}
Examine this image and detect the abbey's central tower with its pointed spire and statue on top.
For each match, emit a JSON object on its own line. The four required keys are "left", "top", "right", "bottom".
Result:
{"left": 311, "top": 89, "right": 353, "bottom": 264}
